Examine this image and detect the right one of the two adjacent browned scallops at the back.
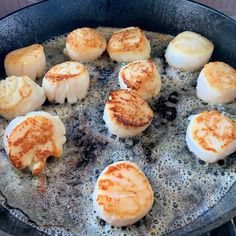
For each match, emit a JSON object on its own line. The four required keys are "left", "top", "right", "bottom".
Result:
{"left": 107, "top": 27, "right": 151, "bottom": 62}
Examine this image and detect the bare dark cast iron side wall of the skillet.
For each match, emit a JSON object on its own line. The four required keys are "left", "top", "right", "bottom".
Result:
{"left": 0, "top": 0, "right": 236, "bottom": 236}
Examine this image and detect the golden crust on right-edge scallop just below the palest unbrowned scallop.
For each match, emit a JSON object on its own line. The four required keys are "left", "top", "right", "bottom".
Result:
{"left": 203, "top": 61, "right": 236, "bottom": 91}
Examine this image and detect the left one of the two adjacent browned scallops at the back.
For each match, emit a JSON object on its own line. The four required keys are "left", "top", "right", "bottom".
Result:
{"left": 66, "top": 27, "right": 106, "bottom": 62}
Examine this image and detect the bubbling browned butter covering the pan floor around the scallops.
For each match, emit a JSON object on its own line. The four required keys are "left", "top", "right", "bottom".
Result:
{"left": 0, "top": 28, "right": 236, "bottom": 235}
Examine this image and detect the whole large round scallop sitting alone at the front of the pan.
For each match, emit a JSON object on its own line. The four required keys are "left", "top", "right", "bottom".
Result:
{"left": 93, "top": 161, "right": 154, "bottom": 227}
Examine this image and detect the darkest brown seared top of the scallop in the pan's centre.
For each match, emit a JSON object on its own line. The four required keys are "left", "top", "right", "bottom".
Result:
{"left": 106, "top": 89, "right": 153, "bottom": 127}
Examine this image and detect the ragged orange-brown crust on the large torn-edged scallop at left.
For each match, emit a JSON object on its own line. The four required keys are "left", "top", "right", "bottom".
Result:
{"left": 7, "top": 116, "right": 61, "bottom": 174}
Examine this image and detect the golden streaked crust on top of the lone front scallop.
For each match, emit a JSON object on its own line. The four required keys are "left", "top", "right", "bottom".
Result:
{"left": 96, "top": 162, "right": 153, "bottom": 219}
